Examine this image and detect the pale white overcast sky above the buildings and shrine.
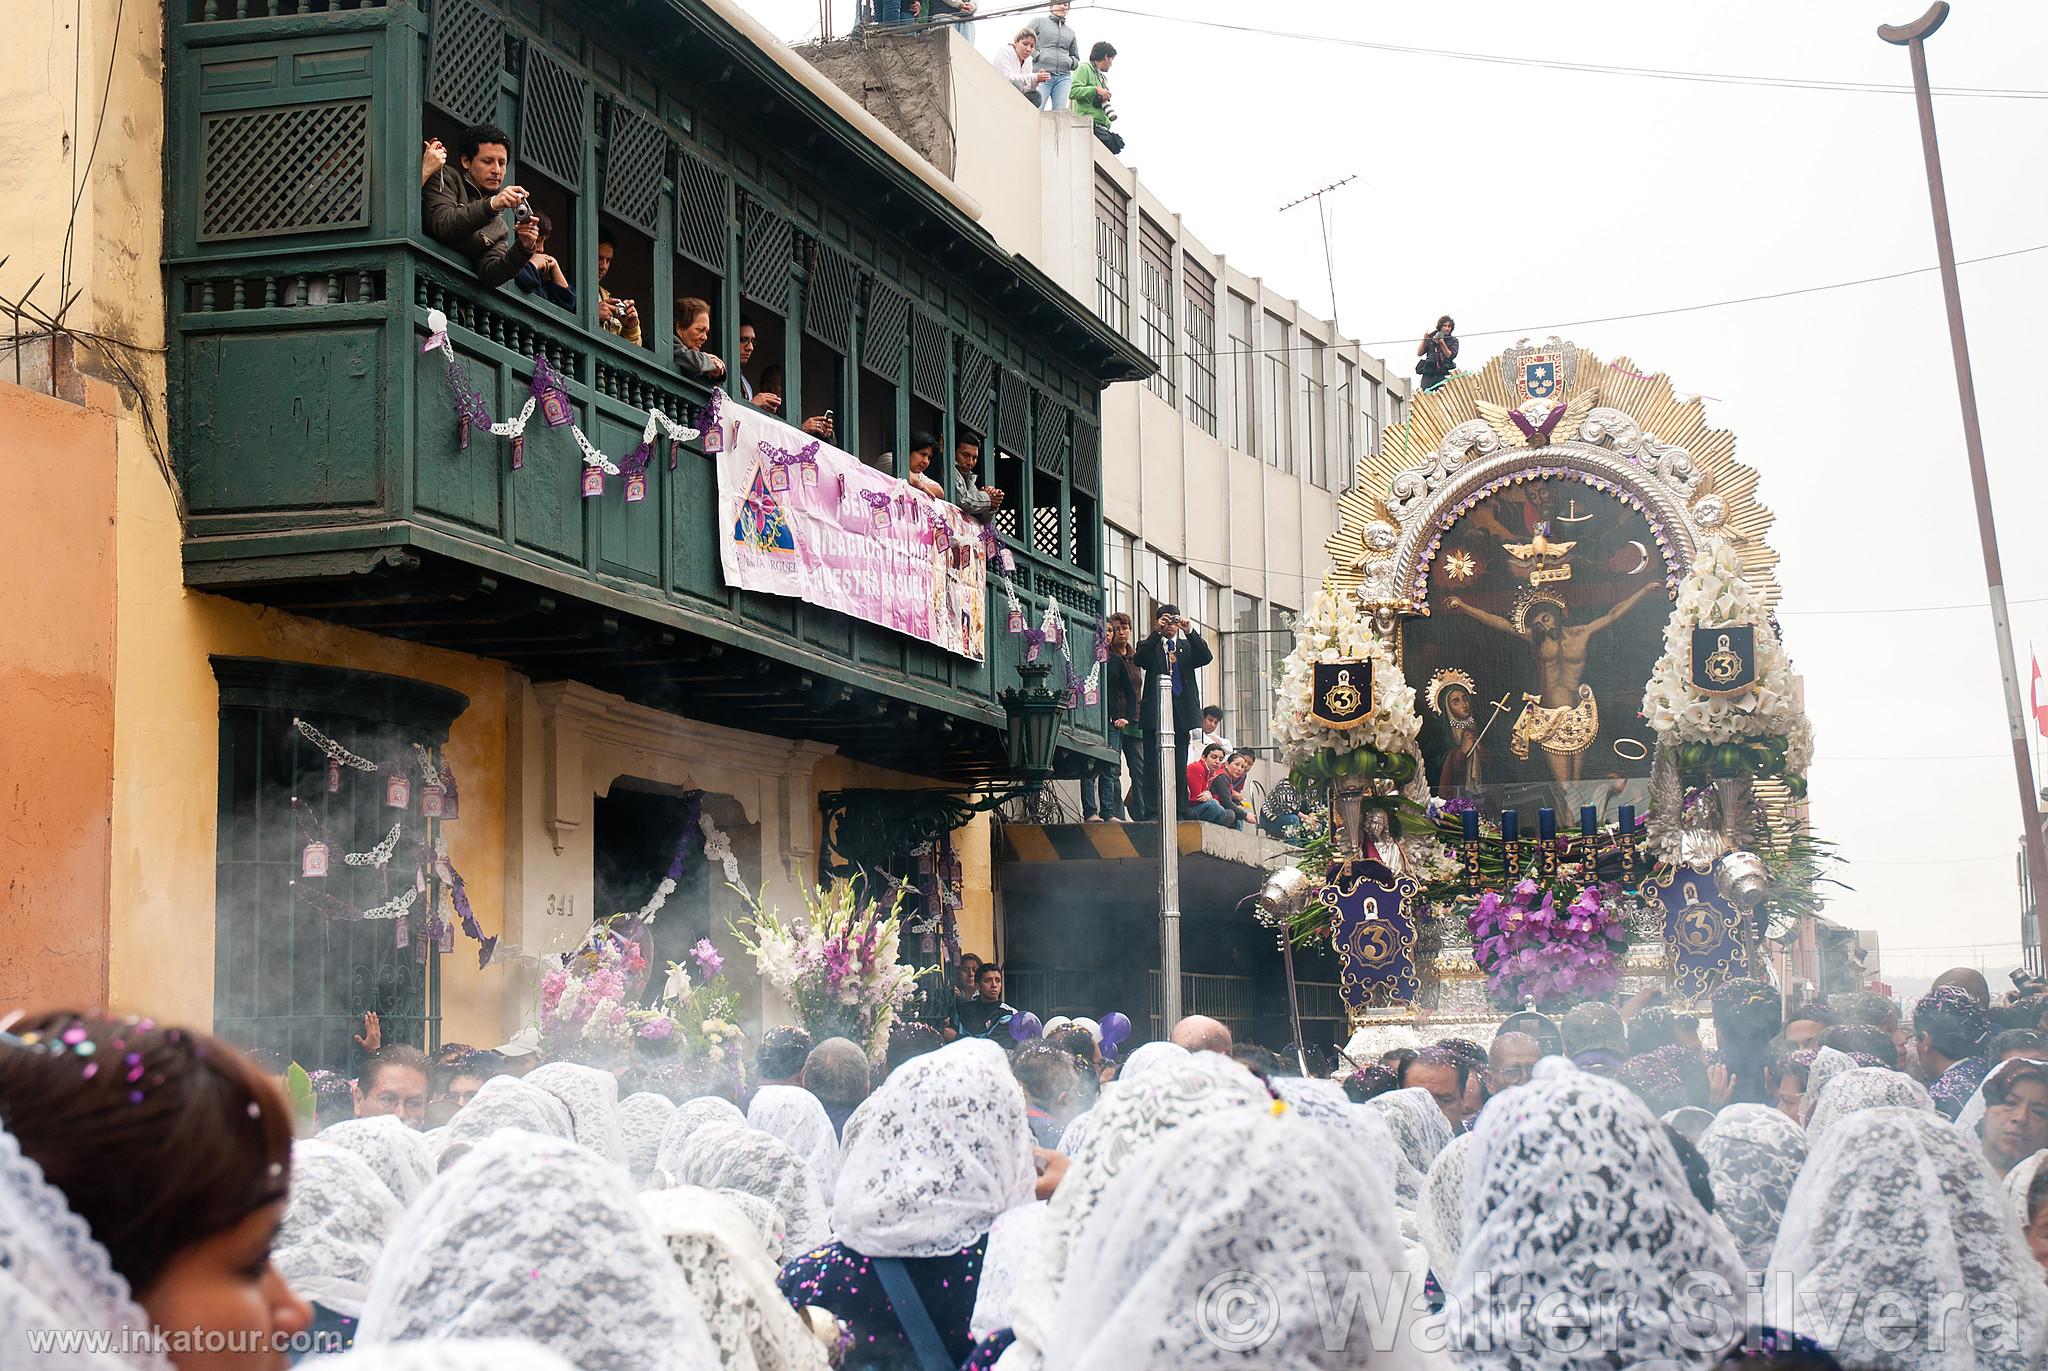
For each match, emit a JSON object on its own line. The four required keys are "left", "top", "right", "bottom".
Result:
{"left": 750, "top": 0, "right": 2048, "bottom": 980}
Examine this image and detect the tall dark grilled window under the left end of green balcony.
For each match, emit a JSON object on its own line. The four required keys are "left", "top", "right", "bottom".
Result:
{"left": 213, "top": 658, "right": 468, "bottom": 1072}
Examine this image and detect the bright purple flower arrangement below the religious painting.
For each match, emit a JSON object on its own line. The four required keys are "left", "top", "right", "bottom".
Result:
{"left": 1466, "top": 877, "right": 1628, "bottom": 1008}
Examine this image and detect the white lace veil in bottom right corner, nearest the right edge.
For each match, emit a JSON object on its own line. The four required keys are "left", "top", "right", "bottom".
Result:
{"left": 1763, "top": 1082, "right": 2048, "bottom": 1371}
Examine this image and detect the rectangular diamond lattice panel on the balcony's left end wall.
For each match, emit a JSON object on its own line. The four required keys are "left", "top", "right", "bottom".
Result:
{"left": 199, "top": 100, "right": 371, "bottom": 242}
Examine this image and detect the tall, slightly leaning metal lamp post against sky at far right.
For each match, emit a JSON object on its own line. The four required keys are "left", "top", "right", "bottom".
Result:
{"left": 1878, "top": 0, "right": 2048, "bottom": 963}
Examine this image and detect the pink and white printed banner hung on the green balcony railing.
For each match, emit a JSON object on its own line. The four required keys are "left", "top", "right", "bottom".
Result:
{"left": 696, "top": 391, "right": 989, "bottom": 662}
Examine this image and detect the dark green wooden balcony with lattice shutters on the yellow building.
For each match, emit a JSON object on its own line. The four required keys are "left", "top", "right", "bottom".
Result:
{"left": 166, "top": 0, "right": 1147, "bottom": 781}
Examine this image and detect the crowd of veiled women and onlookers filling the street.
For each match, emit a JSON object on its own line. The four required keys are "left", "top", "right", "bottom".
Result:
{"left": 12, "top": 967, "right": 2048, "bottom": 1371}
